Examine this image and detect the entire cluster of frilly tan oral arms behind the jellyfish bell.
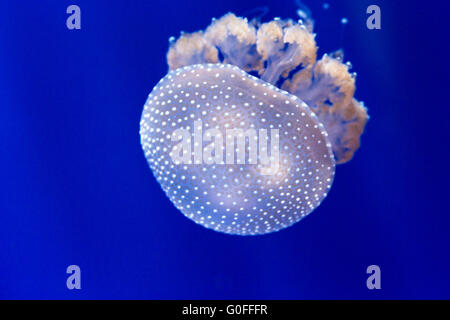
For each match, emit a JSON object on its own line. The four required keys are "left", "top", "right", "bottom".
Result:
{"left": 167, "top": 13, "right": 368, "bottom": 163}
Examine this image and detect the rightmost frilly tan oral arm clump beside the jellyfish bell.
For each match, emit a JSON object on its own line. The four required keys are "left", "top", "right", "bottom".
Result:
{"left": 284, "top": 54, "right": 368, "bottom": 164}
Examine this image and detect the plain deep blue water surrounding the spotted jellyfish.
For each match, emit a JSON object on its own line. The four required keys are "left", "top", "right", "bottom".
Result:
{"left": 0, "top": 0, "right": 450, "bottom": 299}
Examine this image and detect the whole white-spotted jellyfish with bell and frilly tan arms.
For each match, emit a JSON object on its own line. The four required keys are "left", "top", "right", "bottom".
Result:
{"left": 140, "top": 13, "right": 368, "bottom": 235}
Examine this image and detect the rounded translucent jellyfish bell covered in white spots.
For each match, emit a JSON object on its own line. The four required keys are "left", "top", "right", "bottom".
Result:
{"left": 141, "top": 64, "right": 334, "bottom": 235}
